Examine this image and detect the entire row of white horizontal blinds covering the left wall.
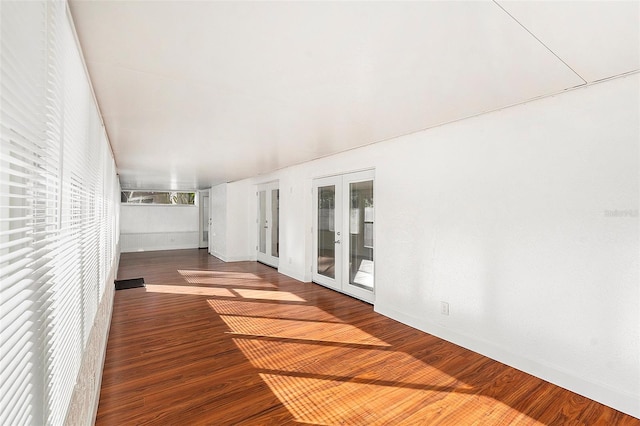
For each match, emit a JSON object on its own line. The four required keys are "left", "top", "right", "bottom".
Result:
{"left": 0, "top": 1, "right": 120, "bottom": 425}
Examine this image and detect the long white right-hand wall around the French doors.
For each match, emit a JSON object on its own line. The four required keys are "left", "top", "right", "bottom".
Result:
{"left": 211, "top": 74, "right": 640, "bottom": 417}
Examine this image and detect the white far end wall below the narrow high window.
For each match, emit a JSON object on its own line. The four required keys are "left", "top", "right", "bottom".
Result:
{"left": 120, "top": 203, "right": 199, "bottom": 253}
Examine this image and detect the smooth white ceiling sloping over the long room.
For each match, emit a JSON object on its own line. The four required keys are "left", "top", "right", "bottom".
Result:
{"left": 70, "top": 0, "right": 640, "bottom": 189}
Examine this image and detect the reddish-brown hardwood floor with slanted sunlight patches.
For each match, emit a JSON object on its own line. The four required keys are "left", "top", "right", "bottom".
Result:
{"left": 96, "top": 250, "right": 640, "bottom": 425}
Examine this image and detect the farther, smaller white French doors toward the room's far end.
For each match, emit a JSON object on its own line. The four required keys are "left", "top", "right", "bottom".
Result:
{"left": 256, "top": 182, "right": 280, "bottom": 268}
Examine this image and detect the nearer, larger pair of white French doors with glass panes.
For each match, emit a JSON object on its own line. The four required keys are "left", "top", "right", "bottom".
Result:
{"left": 313, "top": 170, "right": 374, "bottom": 303}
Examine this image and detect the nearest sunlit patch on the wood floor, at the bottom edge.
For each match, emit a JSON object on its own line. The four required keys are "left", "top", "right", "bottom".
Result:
{"left": 260, "top": 373, "right": 542, "bottom": 425}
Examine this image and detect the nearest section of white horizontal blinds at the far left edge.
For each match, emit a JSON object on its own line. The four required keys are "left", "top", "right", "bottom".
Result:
{"left": 0, "top": 2, "right": 50, "bottom": 424}
